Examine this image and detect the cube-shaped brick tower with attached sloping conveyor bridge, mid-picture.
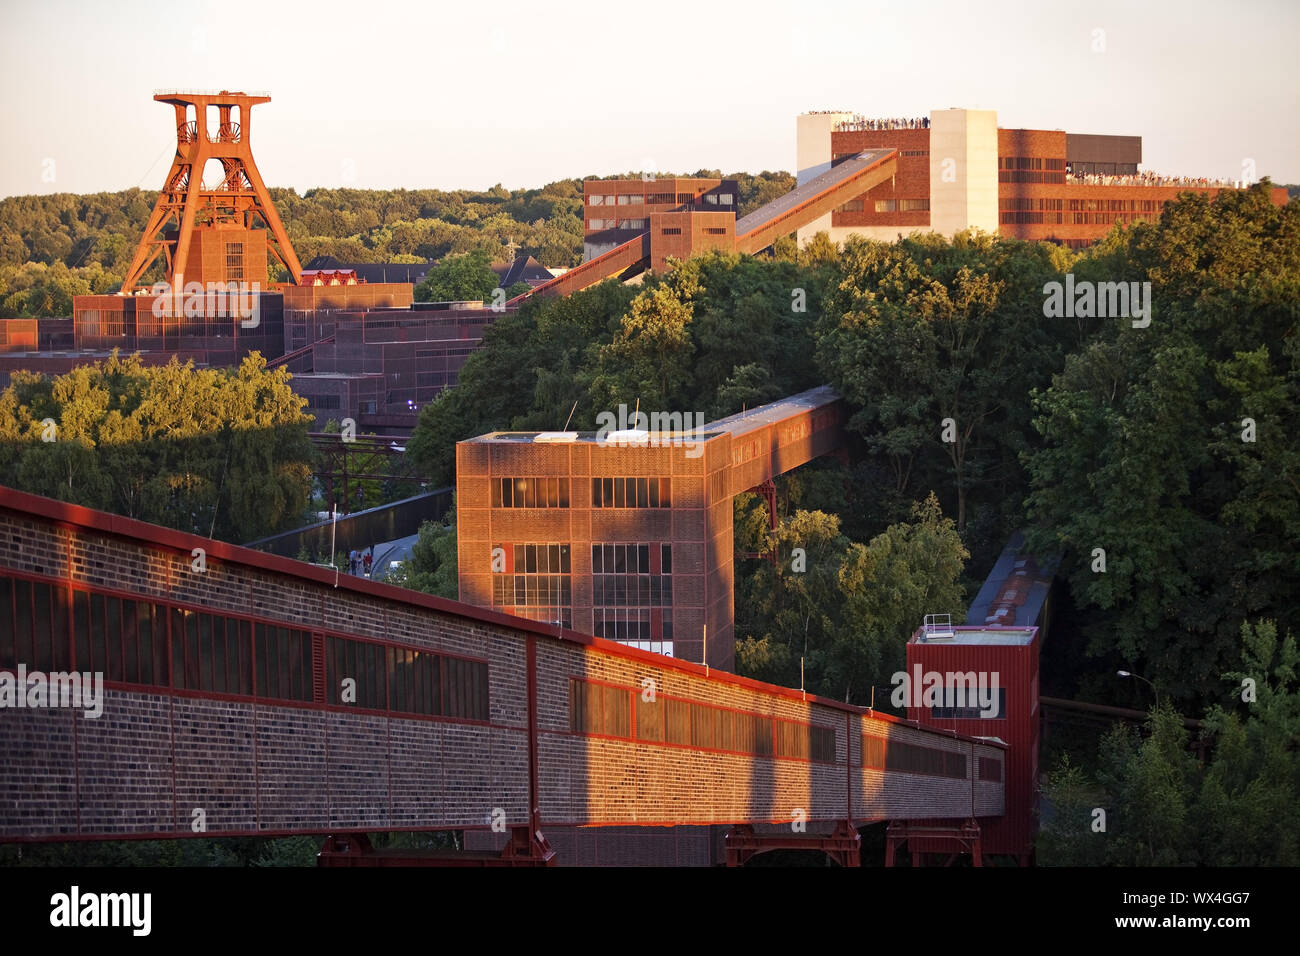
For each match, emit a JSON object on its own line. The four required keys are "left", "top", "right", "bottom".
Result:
{"left": 456, "top": 386, "right": 842, "bottom": 670}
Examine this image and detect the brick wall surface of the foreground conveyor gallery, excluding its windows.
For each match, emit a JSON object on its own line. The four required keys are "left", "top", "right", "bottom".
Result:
{"left": 0, "top": 490, "right": 1002, "bottom": 852}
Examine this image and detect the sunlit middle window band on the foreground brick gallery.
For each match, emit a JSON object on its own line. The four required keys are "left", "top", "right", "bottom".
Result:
{"left": 569, "top": 680, "right": 835, "bottom": 763}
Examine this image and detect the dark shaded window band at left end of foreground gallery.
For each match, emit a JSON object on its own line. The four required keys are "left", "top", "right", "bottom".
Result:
{"left": 0, "top": 578, "right": 488, "bottom": 721}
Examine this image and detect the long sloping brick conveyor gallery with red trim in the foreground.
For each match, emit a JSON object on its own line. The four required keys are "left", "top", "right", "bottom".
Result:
{"left": 0, "top": 489, "right": 1006, "bottom": 864}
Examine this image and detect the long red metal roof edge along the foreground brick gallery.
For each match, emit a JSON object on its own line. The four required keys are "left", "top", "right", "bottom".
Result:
{"left": 0, "top": 485, "right": 1005, "bottom": 749}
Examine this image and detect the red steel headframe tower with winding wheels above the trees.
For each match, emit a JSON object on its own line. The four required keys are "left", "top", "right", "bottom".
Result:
{"left": 122, "top": 90, "right": 302, "bottom": 295}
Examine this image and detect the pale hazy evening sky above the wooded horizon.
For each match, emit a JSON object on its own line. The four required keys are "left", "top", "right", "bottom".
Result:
{"left": 0, "top": 0, "right": 1300, "bottom": 196}
